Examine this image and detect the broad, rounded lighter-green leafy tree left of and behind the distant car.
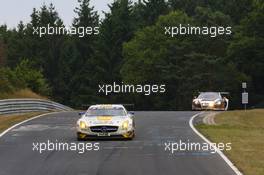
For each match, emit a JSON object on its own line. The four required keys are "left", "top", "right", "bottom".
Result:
{"left": 121, "top": 8, "right": 247, "bottom": 110}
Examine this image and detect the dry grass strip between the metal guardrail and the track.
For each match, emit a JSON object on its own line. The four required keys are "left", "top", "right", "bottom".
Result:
{"left": 0, "top": 112, "right": 43, "bottom": 133}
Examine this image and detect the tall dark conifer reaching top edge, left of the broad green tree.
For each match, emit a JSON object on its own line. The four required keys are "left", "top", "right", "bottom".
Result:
{"left": 79, "top": 0, "right": 135, "bottom": 103}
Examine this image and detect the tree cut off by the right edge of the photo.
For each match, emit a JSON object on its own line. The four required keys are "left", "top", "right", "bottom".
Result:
{"left": 228, "top": 1, "right": 264, "bottom": 104}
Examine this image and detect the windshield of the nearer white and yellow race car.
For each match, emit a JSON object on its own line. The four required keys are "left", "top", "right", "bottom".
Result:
{"left": 86, "top": 108, "right": 126, "bottom": 116}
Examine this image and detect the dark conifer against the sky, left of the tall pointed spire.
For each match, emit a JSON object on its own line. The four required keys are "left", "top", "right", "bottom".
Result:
{"left": 25, "top": 4, "right": 66, "bottom": 100}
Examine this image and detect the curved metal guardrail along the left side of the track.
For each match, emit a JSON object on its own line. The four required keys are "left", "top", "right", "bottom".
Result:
{"left": 0, "top": 99, "right": 73, "bottom": 115}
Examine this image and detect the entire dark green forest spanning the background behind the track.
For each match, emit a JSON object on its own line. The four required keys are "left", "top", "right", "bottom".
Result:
{"left": 0, "top": 0, "right": 264, "bottom": 110}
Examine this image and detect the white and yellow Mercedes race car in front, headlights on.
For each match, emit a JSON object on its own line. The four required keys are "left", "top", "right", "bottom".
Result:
{"left": 77, "top": 105, "right": 135, "bottom": 140}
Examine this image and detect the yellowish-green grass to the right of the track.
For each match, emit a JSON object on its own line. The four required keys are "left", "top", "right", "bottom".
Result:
{"left": 197, "top": 109, "right": 264, "bottom": 175}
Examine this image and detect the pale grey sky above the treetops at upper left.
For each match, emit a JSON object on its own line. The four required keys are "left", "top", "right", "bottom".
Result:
{"left": 0, "top": 0, "right": 113, "bottom": 28}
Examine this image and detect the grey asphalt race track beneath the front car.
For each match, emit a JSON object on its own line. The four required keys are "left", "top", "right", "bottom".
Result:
{"left": 0, "top": 112, "right": 235, "bottom": 175}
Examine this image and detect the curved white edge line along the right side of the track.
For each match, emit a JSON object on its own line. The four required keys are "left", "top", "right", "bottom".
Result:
{"left": 189, "top": 112, "right": 243, "bottom": 175}
